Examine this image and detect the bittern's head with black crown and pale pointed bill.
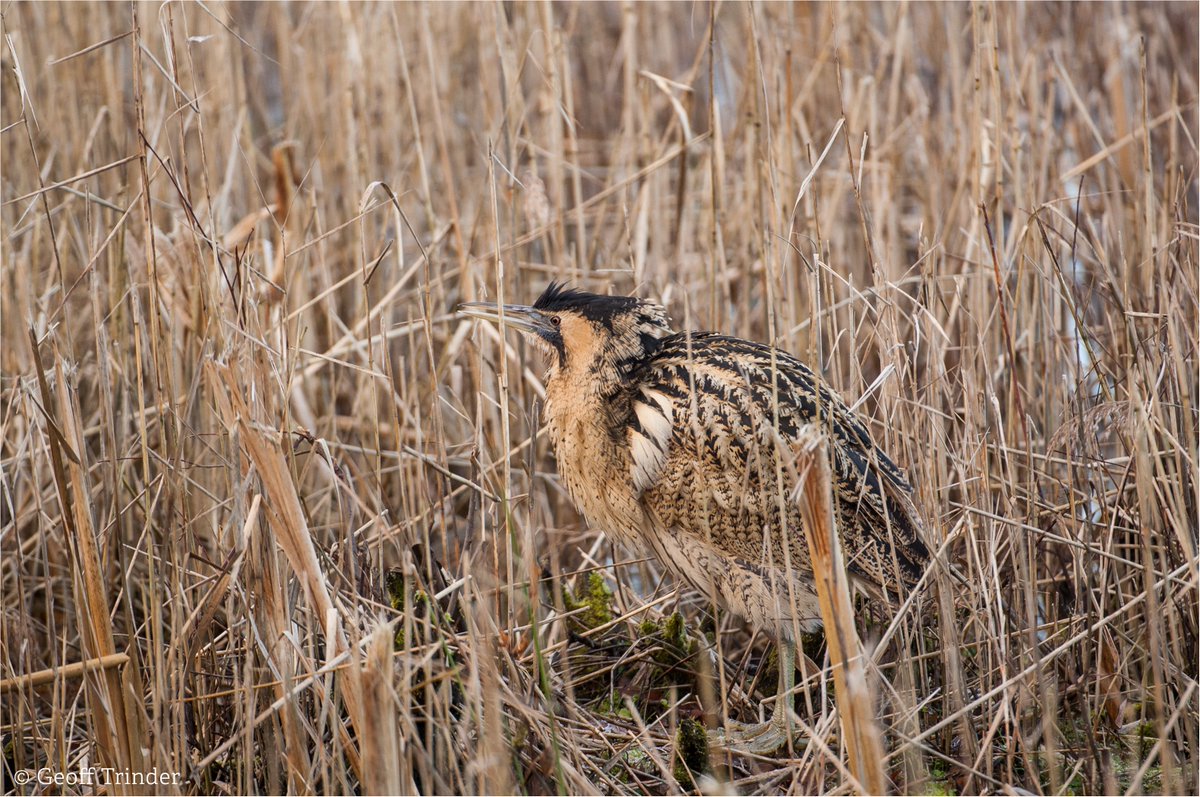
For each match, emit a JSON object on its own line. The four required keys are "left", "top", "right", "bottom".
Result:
{"left": 458, "top": 282, "right": 671, "bottom": 392}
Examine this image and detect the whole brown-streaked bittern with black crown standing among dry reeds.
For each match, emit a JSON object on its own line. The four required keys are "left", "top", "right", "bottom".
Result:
{"left": 460, "top": 283, "right": 929, "bottom": 753}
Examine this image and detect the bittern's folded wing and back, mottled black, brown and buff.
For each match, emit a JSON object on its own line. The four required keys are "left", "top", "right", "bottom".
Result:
{"left": 628, "top": 332, "right": 929, "bottom": 604}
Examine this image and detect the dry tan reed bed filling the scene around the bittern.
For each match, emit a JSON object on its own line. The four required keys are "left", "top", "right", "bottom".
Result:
{"left": 0, "top": 2, "right": 1200, "bottom": 793}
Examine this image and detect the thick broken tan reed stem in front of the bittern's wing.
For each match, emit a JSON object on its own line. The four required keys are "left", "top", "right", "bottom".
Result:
{"left": 794, "top": 425, "right": 887, "bottom": 795}
